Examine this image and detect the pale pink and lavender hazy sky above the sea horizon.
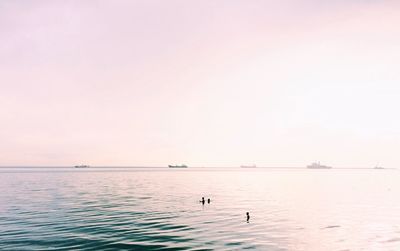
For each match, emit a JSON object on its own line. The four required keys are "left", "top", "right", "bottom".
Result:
{"left": 0, "top": 0, "right": 400, "bottom": 168}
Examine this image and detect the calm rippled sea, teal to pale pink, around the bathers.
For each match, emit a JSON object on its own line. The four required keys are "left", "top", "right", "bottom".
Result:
{"left": 0, "top": 168, "right": 400, "bottom": 251}
